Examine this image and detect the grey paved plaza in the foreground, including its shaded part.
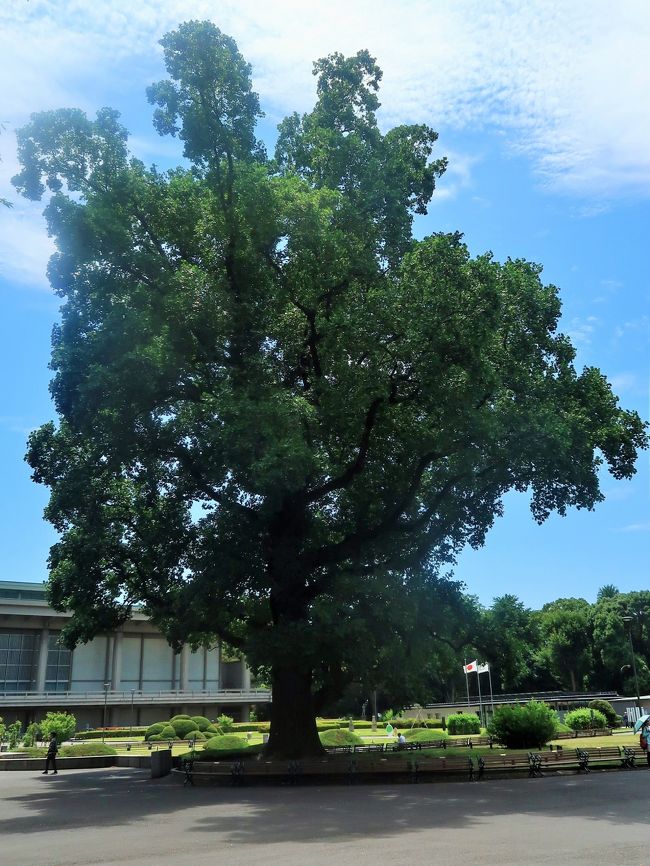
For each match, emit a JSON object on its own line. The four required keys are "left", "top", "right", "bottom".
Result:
{"left": 0, "top": 767, "right": 650, "bottom": 866}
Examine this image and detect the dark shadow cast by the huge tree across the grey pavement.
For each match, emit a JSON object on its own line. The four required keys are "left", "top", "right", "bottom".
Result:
{"left": 0, "top": 768, "right": 650, "bottom": 843}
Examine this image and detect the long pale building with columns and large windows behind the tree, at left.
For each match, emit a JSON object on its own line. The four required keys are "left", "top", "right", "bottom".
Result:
{"left": 0, "top": 581, "right": 271, "bottom": 729}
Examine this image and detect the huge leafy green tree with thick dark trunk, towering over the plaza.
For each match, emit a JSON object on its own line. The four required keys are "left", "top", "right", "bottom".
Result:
{"left": 15, "top": 22, "right": 645, "bottom": 754}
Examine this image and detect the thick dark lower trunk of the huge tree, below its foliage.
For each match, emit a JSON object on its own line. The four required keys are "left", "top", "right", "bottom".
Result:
{"left": 266, "top": 667, "right": 323, "bottom": 758}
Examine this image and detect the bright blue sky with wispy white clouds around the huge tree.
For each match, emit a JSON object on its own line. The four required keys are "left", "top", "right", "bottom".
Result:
{"left": 0, "top": 0, "right": 650, "bottom": 607}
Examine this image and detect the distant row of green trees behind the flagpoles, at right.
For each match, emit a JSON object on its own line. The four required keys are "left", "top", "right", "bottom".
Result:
{"left": 330, "top": 583, "right": 650, "bottom": 714}
